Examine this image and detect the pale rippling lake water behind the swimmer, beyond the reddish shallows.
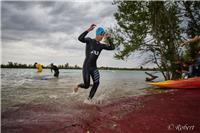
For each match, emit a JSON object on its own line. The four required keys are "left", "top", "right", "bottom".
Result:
{"left": 1, "top": 69, "right": 162, "bottom": 111}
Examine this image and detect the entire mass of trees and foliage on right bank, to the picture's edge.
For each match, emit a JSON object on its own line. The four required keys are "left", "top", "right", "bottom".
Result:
{"left": 109, "top": 1, "right": 200, "bottom": 80}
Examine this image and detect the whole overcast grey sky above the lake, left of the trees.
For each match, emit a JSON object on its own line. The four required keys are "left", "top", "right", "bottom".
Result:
{"left": 1, "top": 1, "right": 145, "bottom": 67}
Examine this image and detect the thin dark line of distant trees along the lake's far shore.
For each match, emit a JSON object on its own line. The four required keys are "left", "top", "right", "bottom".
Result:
{"left": 1, "top": 62, "right": 157, "bottom": 71}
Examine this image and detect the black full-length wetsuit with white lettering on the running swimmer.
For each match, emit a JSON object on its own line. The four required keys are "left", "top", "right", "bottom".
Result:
{"left": 78, "top": 31, "right": 114, "bottom": 99}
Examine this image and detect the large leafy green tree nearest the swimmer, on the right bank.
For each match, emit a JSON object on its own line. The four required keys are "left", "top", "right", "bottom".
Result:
{"left": 111, "top": 1, "right": 189, "bottom": 79}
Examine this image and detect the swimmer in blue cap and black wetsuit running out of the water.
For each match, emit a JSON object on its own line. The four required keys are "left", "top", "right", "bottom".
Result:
{"left": 74, "top": 24, "right": 115, "bottom": 102}
